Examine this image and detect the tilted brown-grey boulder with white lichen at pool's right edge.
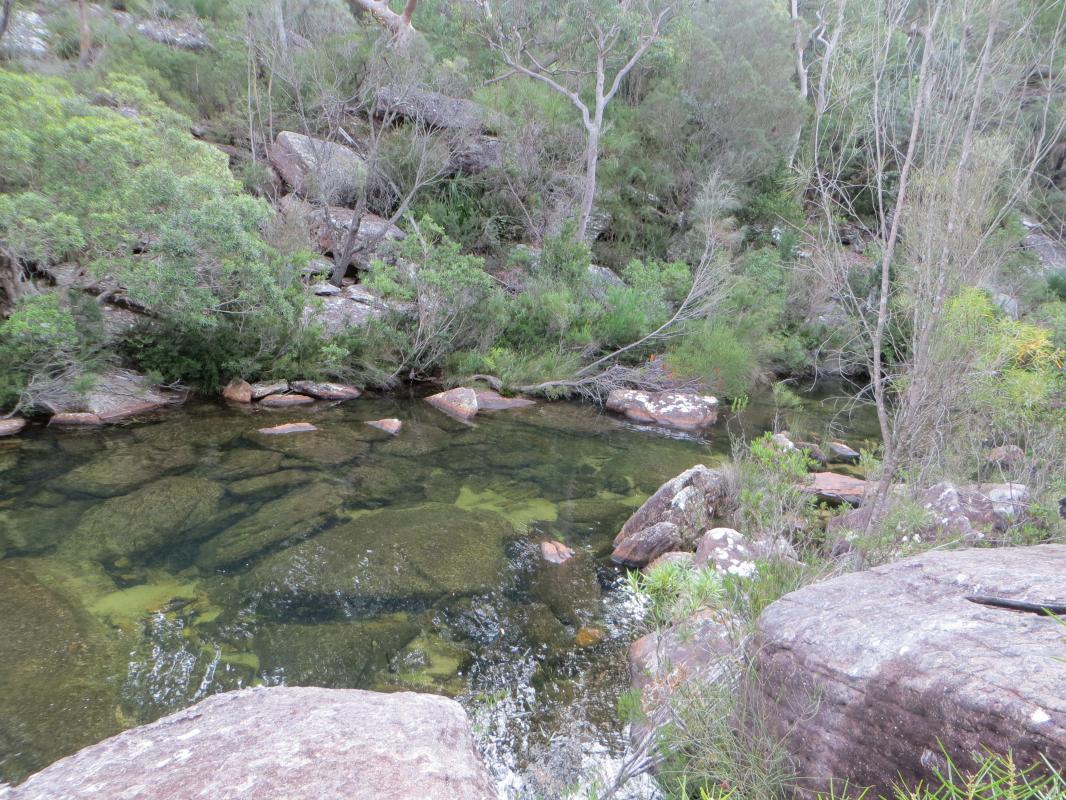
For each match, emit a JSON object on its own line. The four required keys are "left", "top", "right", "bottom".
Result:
{"left": 612, "top": 464, "right": 728, "bottom": 566}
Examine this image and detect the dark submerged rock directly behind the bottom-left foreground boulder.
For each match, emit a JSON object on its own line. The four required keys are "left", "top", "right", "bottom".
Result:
{"left": 254, "top": 613, "right": 419, "bottom": 689}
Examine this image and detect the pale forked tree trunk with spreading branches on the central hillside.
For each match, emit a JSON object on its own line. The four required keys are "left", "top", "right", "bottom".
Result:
{"left": 482, "top": 2, "right": 672, "bottom": 241}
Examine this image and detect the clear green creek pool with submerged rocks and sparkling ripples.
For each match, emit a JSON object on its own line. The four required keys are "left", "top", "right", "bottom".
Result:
{"left": 0, "top": 397, "right": 866, "bottom": 794}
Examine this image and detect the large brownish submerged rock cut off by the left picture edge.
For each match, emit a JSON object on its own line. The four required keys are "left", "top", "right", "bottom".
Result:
{"left": 0, "top": 559, "right": 127, "bottom": 781}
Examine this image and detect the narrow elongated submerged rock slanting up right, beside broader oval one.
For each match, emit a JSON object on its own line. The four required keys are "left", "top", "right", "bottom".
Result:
{"left": 196, "top": 482, "right": 344, "bottom": 570}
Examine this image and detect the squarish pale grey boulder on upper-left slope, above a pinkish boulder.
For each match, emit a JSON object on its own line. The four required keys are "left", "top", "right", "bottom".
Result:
{"left": 267, "top": 130, "right": 367, "bottom": 205}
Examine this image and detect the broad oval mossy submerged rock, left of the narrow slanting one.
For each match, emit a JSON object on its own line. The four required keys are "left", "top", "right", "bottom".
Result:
{"left": 62, "top": 476, "right": 223, "bottom": 562}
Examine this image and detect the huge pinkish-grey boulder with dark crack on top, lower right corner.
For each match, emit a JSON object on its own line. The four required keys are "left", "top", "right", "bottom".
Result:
{"left": 749, "top": 545, "right": 1066, "bottom": 797}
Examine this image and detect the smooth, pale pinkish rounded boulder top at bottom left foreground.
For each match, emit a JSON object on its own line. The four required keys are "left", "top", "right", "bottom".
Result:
{"left": 0, "top": 687, "right": 496, "bottom": 800}
